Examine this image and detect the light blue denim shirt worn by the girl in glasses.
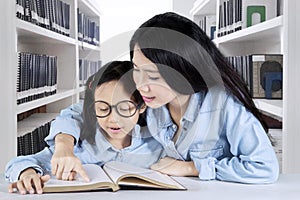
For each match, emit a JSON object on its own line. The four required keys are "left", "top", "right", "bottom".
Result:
{"left": 5, "top": 104, "right": 162, "bottom": 182}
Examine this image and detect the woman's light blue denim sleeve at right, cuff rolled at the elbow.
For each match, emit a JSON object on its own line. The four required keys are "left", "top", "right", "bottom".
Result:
{"left": 214, "top": 96, "right": 279, "bottom": 183}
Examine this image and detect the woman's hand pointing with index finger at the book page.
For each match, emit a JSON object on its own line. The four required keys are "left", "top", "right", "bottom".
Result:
{"left": 51, "top": 133, "right": 89, "bottom": 182}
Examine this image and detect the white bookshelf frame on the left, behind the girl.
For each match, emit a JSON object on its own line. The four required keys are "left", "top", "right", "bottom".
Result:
{"left": 0, "top": 0, "right": 101, "bottom": 171}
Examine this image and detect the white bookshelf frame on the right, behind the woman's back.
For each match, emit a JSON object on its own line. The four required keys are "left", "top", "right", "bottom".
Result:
{"left": 190, "top": 0, "right": 300, "bottom": 173}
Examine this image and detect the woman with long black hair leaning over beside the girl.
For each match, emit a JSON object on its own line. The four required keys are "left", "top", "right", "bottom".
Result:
{"left": 42, "top": 13, "right": 279, "bottom": 183}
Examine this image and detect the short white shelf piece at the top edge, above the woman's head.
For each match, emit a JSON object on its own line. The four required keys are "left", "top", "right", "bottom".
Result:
{"left": 190, "top": 0, "right": 216, "bottom": 15}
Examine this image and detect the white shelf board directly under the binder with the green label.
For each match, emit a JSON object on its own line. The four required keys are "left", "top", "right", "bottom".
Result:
{"left": 214, "top": 16, "right": 283, "bottom": 44}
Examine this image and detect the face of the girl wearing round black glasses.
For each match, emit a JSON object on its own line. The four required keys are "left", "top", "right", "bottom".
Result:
{"left": 95, "top": 81, "right": 142, "bottom": 144}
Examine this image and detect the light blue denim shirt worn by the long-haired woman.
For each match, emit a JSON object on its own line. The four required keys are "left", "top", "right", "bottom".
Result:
{"left": 147, "top": 88, "right": 279, "bottom": 183}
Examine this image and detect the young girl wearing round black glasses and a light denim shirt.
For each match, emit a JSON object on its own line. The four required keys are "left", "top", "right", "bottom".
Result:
{"left": 5, "top": 61, "right": 162, "bottom": 194}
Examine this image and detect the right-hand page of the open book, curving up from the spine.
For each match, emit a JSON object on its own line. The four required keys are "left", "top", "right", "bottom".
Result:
{"left": 103, "top": 161, "right": 185, "bottom": 189}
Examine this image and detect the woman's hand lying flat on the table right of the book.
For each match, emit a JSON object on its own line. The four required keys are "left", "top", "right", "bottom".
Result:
{"left": 150, "top": 157, "right": 199, "bottom": 176}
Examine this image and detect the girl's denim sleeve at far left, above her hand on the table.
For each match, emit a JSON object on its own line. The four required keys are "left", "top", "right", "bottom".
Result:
{"left": 5, "top": 148, "right": 53, "bottom": 182}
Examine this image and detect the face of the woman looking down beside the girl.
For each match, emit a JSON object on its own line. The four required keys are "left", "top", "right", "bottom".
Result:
{"left": 132, "top": 45, "right": 176, "bottom": 108}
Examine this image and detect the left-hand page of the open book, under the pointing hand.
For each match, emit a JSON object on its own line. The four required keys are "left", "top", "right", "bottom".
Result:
{"left": 44, "top": 164, "right": 112, "bottom": 191}
